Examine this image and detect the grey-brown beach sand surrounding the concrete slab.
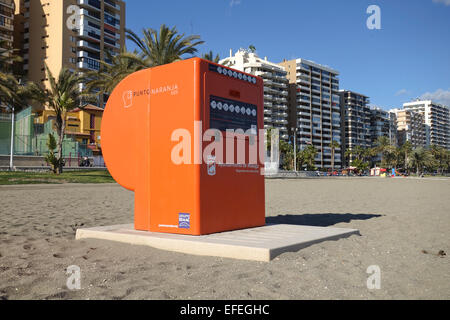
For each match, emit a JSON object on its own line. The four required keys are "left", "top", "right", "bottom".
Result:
{"left": 0, "top": 178, "right": 450, "bottom": 300}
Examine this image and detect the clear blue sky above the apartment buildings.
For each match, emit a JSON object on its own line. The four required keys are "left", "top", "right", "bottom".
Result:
{"left": 126, "top": 0, "right": 450, "bottom": 109}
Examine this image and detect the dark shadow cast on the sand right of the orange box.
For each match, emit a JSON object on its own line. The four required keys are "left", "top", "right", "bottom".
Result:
{"left": 266, "top": 213, "right": 382, "bottom": 227}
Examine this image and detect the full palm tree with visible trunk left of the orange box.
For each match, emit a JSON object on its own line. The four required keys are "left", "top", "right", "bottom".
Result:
{"left": 26, "top": 65, "right": 83, "bottom": 174}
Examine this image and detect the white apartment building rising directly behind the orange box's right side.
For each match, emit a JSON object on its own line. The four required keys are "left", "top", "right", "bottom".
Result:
{"left": 220, "top": 49, "right": 289, "bottom": 140}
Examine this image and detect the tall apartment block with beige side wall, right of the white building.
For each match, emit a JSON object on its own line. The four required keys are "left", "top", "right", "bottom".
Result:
{"left": 280, "top": 59, "right": 342, "bottom": 169}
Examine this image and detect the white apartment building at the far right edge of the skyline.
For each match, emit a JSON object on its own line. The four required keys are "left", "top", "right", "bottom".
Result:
{"left": 403, "top": 100, "right": 450, "bottom": 150}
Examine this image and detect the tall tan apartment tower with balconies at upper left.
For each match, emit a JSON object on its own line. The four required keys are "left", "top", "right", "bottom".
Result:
{"left": 15, "top": 0, "right": 125, "bottom": 109}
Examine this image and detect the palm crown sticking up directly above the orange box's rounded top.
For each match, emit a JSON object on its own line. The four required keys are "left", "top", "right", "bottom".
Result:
{"left": 126, "top": 24, "right": 204, "bottom": 67}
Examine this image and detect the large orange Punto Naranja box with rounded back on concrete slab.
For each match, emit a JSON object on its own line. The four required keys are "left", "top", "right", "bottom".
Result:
{"left": 101, "top": 58, "right": 265, "bottom": 235}
